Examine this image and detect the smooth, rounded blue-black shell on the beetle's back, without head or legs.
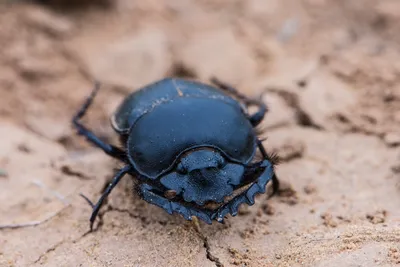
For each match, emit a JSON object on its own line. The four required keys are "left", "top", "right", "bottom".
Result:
{"left": 111, "top": 78, "right": 256, "bottom": 179}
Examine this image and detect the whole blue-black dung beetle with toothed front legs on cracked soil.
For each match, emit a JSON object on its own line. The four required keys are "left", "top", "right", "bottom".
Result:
{"left": 72, "top": 78, "right": 279, "bottom": 229}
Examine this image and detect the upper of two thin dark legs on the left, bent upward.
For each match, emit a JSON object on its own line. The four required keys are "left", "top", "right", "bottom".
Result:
{"left": 72, "top": 83, "right": 126, "bottom": 161}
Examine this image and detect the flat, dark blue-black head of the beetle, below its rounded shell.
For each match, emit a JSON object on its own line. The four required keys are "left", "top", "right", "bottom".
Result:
{"left": 160, "top": 149, "right": 244, "bottom": 205}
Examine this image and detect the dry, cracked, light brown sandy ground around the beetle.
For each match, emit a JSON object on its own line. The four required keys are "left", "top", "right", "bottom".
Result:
{"left": 0, "top": 0, "right": 400, "bottom": 266}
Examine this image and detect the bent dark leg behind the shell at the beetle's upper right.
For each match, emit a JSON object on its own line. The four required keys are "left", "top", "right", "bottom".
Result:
{"left": 211, "top": 77, "right": 268, "bottom": 127}
